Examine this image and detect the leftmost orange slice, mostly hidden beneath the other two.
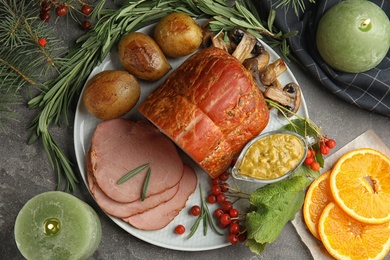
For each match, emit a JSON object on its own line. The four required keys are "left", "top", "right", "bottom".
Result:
{"left": 303, "top": 171, "right": 332, "bottom": 239}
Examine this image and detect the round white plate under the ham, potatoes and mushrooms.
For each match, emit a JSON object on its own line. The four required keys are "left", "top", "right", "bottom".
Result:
{"left": 74, "top": 22, "right": 308, "bottom": 251}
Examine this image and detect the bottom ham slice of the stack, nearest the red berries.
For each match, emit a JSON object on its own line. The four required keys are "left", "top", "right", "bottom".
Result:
{"left": 123, "top": 165, "right": 197, "bottom": 230}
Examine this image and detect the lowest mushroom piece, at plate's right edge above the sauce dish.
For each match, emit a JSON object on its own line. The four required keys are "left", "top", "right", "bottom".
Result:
{"left": 264, "top": 82, "right": 301, "bottom": 117}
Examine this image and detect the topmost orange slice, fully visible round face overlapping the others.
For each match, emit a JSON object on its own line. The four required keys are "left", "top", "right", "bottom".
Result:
{"left": 329, "top": 148, "right": 390, "bottom": 224}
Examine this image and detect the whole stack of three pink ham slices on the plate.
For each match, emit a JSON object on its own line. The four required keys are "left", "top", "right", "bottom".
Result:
{"left": 87, "top": 118, "right": 197, "bottom": 230}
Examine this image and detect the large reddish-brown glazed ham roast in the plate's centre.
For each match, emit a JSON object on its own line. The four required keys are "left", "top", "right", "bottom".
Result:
{"left": 139, "top": 48, "right": 269, "bottom": 178}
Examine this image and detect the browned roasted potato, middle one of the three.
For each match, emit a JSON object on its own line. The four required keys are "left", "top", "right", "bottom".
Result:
{"left": 118, "top": 32, "right": 172, "bottom": 81}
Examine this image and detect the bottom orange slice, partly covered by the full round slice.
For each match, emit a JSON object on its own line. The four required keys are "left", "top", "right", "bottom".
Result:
{"left": 318, "top": 202, "right": 390, "bottom": 260}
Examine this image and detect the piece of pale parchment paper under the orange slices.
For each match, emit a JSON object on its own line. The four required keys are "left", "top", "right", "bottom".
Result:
{"left": 292, "top": 130, "right": 390, "bottom": 260}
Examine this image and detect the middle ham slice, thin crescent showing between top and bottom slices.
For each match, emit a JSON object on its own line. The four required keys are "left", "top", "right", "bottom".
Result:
{"left": 88, "top": 160, "right": 179, "bottom": 218}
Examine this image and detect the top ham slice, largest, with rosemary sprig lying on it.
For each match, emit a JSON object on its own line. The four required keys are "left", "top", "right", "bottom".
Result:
{"left": 87, "top": 118, "right": 184, "bottom": 203}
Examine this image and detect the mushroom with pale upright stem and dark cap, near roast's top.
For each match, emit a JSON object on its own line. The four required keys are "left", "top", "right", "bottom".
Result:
{"left": 229, "top": 27, "right": 264, "bottom": 62}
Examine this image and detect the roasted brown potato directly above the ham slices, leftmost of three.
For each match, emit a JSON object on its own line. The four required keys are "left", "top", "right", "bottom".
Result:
{"left": 83, "top": 70, "right": 141, "bottom": 120}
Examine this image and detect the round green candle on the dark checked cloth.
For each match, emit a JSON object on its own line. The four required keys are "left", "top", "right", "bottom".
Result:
{"left": 316, "top": 0, "right": 390, "bottom": 73}
